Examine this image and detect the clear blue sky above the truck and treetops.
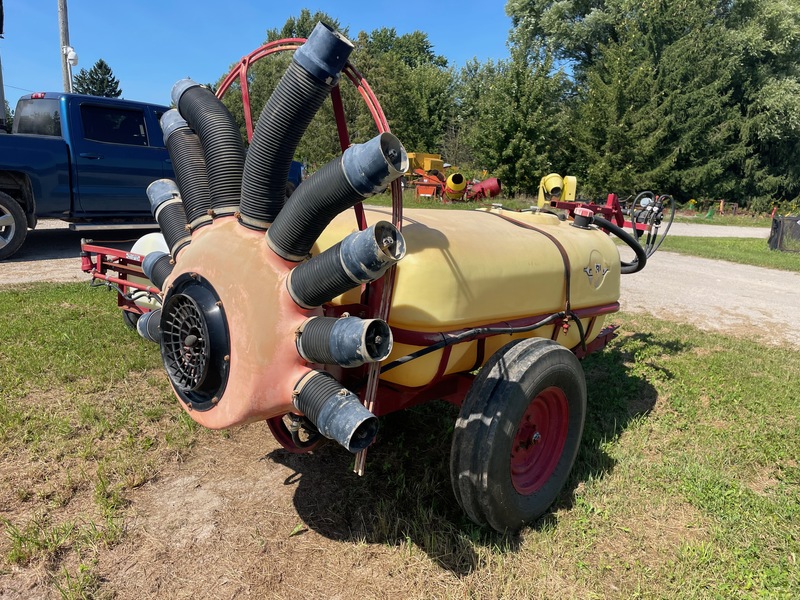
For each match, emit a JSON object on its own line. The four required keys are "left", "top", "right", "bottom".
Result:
{"left": 0, "top": 0, "right": 511, "bottom": 108}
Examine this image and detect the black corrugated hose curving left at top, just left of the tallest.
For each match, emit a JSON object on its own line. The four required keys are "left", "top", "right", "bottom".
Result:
{"left": 172, "top": 79, "right": 244, "bottom": 217}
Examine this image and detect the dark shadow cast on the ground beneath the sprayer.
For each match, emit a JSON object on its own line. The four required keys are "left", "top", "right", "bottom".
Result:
{"left": 268, "top": 334, "right": 684, "bottom": 576}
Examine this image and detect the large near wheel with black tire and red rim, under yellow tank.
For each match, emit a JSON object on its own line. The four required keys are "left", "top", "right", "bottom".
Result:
{"left": 450, "top": 338, "right": 586, "bottom": 532}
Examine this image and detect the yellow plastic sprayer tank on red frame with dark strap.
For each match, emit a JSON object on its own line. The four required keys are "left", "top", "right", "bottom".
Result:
{"left": 312, "top": 206, "right": 620, "bottom": 387}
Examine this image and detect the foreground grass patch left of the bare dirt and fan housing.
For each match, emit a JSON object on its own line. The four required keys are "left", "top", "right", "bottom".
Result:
{"left": 0, "top": 284, "right": 206, "bottom": 597}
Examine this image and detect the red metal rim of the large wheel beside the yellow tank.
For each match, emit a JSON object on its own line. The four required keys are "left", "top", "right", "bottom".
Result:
{"left": 511, "top": 387, "right": 569, "bottom": 495}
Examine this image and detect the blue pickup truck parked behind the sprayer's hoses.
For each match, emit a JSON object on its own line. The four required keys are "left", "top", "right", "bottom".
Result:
{"left": 0, "top": 92, "right": 174, "bottom": 260}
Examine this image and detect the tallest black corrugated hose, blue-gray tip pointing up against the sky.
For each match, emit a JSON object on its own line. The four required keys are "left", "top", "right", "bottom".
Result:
{"left": 239, "top": 23, "right": 353, "bottom": 231}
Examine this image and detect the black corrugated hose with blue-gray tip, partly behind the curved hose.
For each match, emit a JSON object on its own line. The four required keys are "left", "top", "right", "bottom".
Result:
{"left": 161, "top": 108, "right": 212, "bottom": 231}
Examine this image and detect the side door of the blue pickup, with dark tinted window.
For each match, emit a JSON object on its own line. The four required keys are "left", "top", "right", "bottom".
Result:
{"left": 71, "top": 100, "right": 167, "bottom": 219}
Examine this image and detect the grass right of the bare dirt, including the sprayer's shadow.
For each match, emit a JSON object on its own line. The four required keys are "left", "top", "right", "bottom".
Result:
{"left": 310, "top": 315, "right": 800, "bottom": 598}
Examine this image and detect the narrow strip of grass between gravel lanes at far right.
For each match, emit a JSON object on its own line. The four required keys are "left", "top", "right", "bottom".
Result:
{"left": 661, "top": 235, "right": 800, "bottom": 272}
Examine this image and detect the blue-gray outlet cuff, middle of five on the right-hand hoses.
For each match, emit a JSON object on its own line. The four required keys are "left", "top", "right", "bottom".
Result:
{"left": 340, "top": 221, "right": 406, "bottom": 283}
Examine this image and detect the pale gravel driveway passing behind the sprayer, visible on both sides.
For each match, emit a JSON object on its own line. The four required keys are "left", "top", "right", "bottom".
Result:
{"left": 0, "top": 221, "right": 800, "bottom": 348}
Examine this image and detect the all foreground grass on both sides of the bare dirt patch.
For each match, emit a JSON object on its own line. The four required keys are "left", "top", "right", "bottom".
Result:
{"left": 0, "top": 284, "right": 800, "bottom": 598}
